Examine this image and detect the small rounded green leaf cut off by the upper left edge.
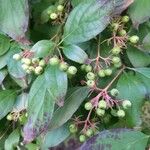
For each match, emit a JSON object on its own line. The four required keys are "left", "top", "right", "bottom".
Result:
{"left": 0, "top": 34, "right": 10, "bottom": 56}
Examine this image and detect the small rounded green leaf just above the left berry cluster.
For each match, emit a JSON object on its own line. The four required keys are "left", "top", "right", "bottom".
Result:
{"left": 31, "top": 40, "right": 55, "bottom": 58}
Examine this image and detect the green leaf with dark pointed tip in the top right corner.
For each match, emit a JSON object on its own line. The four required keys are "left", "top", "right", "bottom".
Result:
{"left": 128, "top": 0, "right": 150, "bottom": 28}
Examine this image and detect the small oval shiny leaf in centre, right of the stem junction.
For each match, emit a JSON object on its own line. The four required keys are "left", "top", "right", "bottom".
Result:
{"left": 63, "top": 45, "right": 88, "bottom": 64}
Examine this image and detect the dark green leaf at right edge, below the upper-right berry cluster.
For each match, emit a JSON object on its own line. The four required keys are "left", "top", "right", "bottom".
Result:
{"left": 127, "top": 46, "right": 150, "bottom": 67}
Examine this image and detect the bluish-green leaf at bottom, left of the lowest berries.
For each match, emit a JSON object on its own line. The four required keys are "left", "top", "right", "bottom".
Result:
{"left": 41, "top": 124, "right": 70, "bottom": 150}
